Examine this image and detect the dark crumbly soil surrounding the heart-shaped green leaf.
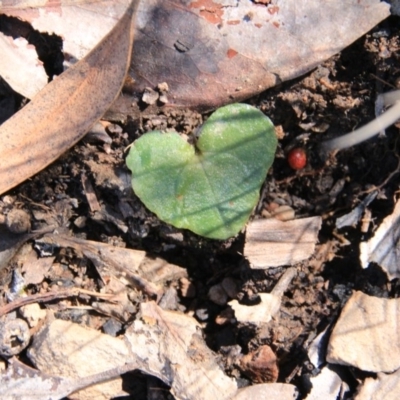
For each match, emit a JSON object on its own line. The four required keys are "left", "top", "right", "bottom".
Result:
{"left": 0, "top": 13, "right": 400, "bottom": 399}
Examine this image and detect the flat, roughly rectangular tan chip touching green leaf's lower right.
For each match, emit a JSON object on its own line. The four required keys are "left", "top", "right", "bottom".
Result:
{"left": 243, "top": 217, "right": 322, "bottom": 268}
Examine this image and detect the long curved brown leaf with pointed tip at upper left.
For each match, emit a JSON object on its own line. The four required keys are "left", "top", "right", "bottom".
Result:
{"left": 0, "top": 0, "right": 138, "bottom": 193}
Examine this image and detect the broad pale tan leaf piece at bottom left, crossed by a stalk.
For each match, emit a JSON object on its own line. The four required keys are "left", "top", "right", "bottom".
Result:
{"left": 28, "top": 319, "right": 138, "bottom": 400}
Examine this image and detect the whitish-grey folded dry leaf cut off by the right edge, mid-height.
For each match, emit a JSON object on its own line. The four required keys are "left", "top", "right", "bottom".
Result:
{"left": 360, "top": 200, "right": 400, "bottom": 280}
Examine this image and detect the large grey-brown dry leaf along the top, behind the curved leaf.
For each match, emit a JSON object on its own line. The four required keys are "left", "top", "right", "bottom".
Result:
{"left": 0, "top": 0, "right": 389, "bottom": 114}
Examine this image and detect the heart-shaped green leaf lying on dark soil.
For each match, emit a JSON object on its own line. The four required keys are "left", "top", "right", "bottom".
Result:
{"left": 126, "top": 104, "right": 277, "bottom": 239}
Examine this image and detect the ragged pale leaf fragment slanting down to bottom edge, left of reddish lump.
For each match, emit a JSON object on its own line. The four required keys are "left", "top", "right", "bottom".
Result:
{"left": 125, "top": 302, "right": 237, "bottom": 400}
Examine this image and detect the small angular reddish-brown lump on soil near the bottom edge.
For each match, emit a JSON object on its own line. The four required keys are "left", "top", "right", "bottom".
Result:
{"left": 240, "top": 345, "right": 279, "bottom": 383}
